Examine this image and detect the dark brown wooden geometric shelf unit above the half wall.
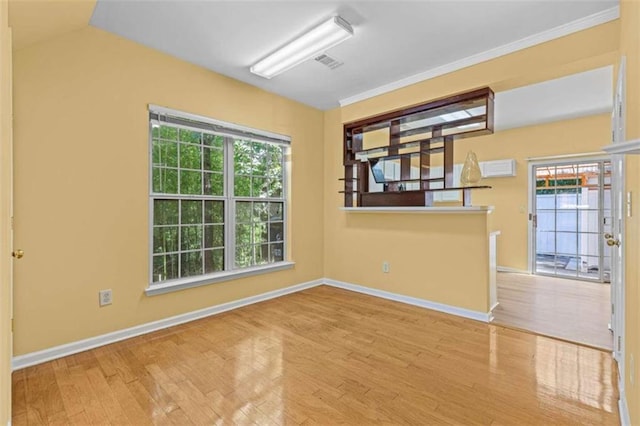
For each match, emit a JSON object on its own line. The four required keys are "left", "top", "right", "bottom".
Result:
{"left": 340, "top": 87, "right": 494, "bottom": 207}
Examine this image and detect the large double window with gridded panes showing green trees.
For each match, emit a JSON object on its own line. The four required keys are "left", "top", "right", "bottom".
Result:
{"left": 149, "top": 107, "right": 289, "bottom": 285}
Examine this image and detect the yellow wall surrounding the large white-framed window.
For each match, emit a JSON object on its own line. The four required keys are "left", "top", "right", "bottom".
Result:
{"left": 14, "top": 27, "right": 323, "bottom": 355}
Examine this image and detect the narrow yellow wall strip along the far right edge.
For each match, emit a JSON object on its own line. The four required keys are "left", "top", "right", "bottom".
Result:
{"left": 620, "top": 0, "right": 640, "bottom": 425}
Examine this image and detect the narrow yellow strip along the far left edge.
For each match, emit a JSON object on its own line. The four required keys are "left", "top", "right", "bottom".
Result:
{"left": 0, "top": 1, "right": 12, "bottom": 425}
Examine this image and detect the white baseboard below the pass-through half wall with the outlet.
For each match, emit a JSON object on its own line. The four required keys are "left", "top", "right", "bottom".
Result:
{"left": 324, "top": 278, "right": 491, "bottom": 322}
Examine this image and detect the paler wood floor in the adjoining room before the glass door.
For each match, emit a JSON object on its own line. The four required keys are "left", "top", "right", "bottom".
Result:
{"left": 493, "top": 272, "right": 613, "bottom": 350}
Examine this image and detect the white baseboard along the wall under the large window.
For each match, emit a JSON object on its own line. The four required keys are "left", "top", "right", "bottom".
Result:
{"left": 11, "top": 279, "right": 324, "bottom": 371}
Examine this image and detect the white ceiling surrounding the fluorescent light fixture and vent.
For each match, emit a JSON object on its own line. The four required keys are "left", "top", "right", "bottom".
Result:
{"left": 91, "top": 0, "right": 619, "bottom": 109}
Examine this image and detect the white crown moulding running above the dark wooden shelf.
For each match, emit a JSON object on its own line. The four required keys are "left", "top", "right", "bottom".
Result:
{"left": 339, "top": 6, "right": 620, "bottom": 107}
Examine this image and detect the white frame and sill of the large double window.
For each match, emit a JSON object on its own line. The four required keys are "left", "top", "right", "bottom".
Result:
{"left": 145, "top": 104, "right": 295, "bottom": 296}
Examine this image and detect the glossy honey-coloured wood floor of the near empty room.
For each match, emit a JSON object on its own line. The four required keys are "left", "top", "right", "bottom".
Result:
{"left": 13, "top": 286, "right": 619, "bottom": 426}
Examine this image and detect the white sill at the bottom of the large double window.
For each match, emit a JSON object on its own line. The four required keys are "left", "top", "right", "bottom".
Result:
{"left": 144, "top": 262, "right": 295, "bottom": 296}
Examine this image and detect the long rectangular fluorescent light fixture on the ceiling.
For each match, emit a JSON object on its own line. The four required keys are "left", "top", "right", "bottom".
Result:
{"left": 250, "top": 16, "right": 353, "bottom": 78}
